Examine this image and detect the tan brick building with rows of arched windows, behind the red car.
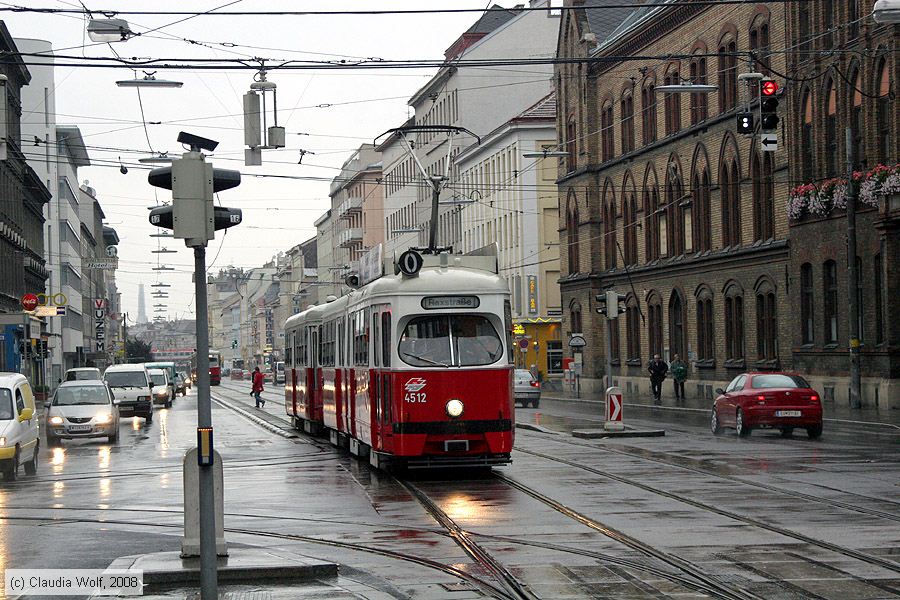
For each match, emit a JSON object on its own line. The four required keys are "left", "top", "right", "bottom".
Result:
{"left": 556, "top": 0, "right": 792, "bottom": 398}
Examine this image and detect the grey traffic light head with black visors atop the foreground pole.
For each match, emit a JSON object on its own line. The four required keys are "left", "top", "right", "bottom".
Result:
{"left": 147, "top": 132, "right": 242, "bottom": 246}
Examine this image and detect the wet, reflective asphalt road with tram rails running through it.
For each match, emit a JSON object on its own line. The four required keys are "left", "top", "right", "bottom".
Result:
{"left": 0, "top": 382, "right": 900, "bottom": 600}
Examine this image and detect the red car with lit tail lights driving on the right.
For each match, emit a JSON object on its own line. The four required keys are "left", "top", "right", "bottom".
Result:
{"left": 710, "top": 373, "right": 822, "bottom": 439}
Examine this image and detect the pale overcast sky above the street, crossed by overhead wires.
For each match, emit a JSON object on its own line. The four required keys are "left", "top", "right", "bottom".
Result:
{"left": 0, "top": 0, "right": 536, "bottom": 319}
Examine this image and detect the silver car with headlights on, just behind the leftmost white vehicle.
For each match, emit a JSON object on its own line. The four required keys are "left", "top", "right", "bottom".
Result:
{"left": 44, "top": 381, "right": 119, "bottom": 446}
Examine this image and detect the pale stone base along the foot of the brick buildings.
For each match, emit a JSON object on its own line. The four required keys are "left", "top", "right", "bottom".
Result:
{"left": 576, "top": 376, "right": 900, "bottom": 409}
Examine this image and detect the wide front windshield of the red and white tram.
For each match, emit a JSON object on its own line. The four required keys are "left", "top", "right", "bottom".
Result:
{"left": 398, "top": 315, "right": 503, "bottom": 367}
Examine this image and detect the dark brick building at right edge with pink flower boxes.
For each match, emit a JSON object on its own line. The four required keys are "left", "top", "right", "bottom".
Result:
{"left": 785, "top": 0, "right": 900, "bottom": 407}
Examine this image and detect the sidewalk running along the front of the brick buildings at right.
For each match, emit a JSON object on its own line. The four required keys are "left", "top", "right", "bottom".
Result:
{"left": 541, "top": 380, "right": 900, "bottom": 430}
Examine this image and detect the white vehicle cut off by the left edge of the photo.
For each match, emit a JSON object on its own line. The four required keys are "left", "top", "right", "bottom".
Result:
{"left": 0, "top": 373, "right": 40, "bottom": 481}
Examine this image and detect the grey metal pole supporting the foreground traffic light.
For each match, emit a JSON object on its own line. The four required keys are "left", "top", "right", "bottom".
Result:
{"left": 194, "top": 246, "right": 219, "bottom": 600}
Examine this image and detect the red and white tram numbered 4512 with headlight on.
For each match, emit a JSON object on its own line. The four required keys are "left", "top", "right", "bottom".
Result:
{"left": 284, "top": 248, "right": 515, "bottom": 468}
